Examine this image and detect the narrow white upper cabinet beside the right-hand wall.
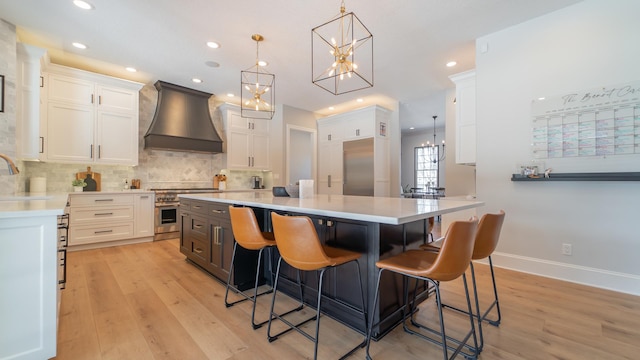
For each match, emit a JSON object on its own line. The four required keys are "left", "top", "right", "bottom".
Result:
{"left": 449, "top": 70, "right": 476, "bottom": 164}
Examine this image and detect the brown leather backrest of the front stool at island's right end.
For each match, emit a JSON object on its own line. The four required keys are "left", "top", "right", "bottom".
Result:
{"left": 424, "top": 218, "right": 478, "bottom": 281}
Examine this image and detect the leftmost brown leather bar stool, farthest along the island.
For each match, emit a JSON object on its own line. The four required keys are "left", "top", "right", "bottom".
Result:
{"left": 224, "top": 206, "right": 302, "bottom": 329}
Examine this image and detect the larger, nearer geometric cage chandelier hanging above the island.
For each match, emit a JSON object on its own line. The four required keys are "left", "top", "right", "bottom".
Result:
{"left": 311, "top": 1, "right": 373, "bottom": 95}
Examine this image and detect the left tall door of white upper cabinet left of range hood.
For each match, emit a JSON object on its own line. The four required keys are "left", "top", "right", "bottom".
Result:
{"left": 44, "top": 102, "right": 96, "bottom": 163}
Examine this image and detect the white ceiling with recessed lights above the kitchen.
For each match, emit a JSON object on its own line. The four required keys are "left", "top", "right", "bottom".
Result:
{"left": 0, "top": 0, "right": 579, "bottom": 129}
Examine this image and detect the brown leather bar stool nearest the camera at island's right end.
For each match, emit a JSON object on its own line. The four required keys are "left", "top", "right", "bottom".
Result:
{"left": 366, "top": 219, "right": 478, "bottom": 360}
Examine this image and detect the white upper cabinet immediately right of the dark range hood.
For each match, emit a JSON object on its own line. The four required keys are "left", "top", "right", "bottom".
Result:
{"left": 220, "top": 104, "right": 271, "bottom": 170}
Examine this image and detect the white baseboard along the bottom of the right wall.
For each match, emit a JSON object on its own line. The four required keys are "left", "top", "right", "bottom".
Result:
{"left": 481, "top": 252, "right": 640, "bottom": 295}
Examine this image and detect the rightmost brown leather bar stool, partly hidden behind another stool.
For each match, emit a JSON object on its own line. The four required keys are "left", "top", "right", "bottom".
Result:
{"left": 420, "top": 210, "right": 505, "bottom": 351}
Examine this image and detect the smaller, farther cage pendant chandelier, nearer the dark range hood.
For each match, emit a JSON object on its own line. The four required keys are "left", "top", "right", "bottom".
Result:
{"left": 240, "top": 34, "right": 276, "bottom": 120}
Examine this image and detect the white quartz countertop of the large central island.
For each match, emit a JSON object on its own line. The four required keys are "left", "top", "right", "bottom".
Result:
{"left": 178, "top": 191, "right": 484, "bottom": 225}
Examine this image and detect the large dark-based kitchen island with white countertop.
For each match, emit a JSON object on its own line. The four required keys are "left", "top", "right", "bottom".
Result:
{"left": 180, "top": 192, "right": 483, "bottom": 338}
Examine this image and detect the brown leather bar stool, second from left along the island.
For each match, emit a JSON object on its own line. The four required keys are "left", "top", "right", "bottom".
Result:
{"left": 267, "top": 213, "right": 364, "bottom": 359}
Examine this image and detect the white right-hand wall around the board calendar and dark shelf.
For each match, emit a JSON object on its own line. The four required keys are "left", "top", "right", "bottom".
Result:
{"left": 476, "top": 0, "right": 640, "bottom": 295}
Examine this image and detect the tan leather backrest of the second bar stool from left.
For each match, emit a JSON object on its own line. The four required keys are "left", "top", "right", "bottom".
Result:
{"left": 271, "top": 213, "right": 333, "bottom": 271}
